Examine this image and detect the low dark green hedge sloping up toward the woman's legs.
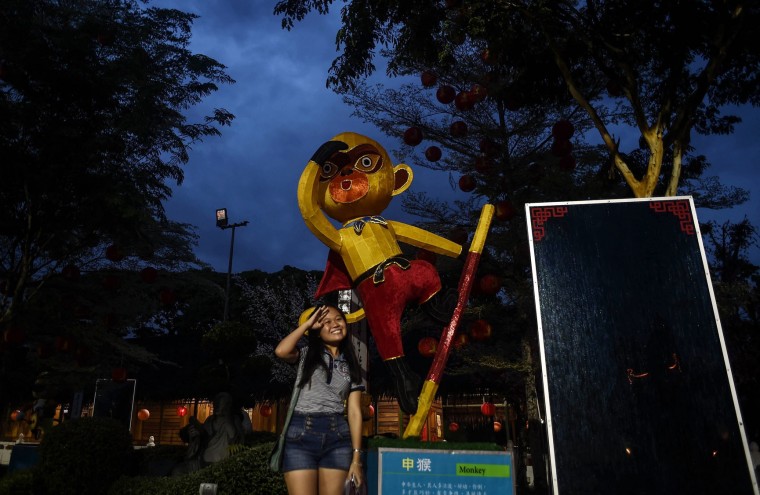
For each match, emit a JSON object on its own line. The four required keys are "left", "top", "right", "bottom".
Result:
{"left": 108, "top": 443, "right": 287, "bottom": 495}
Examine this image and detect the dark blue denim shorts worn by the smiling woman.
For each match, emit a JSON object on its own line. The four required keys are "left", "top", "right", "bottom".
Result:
{"left": 282, "top": 413, "right": 353, "bottom": 472}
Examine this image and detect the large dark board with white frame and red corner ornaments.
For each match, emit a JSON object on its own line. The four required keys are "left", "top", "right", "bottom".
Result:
{"left": 526, "top": 198, "right": 758, "bottom": 495}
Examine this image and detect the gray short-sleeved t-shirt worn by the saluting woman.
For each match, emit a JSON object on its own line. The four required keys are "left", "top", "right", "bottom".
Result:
{"left": 295, "top": 347, "right": 364, "bottom": 414}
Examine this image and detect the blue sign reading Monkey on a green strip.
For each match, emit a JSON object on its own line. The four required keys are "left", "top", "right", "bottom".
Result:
{"left": 377, "top": 448, "right": 514, "bottom": 495}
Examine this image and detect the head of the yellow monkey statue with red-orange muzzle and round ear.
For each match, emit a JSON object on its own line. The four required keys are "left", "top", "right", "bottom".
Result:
{"left": 317, "top": 132, "right": 412, "bottom": 223}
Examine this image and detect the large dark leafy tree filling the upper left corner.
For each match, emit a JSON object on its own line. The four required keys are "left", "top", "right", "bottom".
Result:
{"left": 0, "top": 0, "right": 234, "bottom": 330}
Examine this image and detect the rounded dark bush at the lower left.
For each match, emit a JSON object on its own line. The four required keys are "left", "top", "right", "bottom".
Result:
{"left": 35, "top": 418, "right": 134, "bottom": 495}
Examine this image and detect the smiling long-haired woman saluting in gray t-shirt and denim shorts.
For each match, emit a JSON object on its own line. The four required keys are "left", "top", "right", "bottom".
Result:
{"left": 274, "top": 306, "right": 364, "bottom": 495}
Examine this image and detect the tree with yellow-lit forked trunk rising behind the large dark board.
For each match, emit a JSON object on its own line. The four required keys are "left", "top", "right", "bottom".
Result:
{"left": 274, "top": 0, "right": 760, "bottom": 199}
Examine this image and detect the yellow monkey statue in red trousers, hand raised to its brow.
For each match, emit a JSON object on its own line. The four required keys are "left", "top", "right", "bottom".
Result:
{"left": 298, "top": 132, "right": 462, "bottom": 414}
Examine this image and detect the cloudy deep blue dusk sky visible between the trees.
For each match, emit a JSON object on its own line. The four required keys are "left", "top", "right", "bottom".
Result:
{"left": 150, "top": 0, "right": 760, "bottom": 273}
